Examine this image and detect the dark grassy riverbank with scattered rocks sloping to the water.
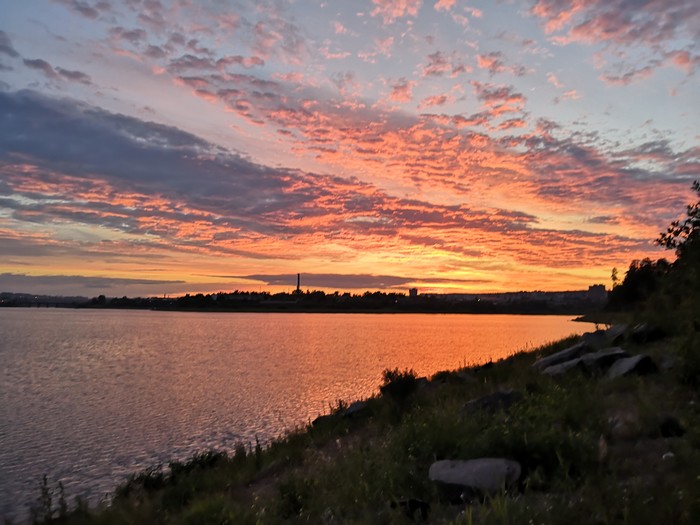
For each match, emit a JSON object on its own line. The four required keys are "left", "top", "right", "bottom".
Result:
{"left": 36, "top": 322, "right": 700, "bottom": 525}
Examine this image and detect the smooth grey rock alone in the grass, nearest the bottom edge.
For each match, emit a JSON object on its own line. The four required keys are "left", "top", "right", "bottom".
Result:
{"left": 428, "top": 458, "right": 522, "bottom": 496}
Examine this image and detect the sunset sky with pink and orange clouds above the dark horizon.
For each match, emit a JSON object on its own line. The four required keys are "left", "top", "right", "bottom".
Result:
{"left": 0, "top": 0, "right": 700, "bottom": 297}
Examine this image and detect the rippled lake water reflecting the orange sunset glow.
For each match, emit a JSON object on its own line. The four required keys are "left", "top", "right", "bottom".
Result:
{"left": 0, "top": 308, "right": 591, "bottom": 520}
